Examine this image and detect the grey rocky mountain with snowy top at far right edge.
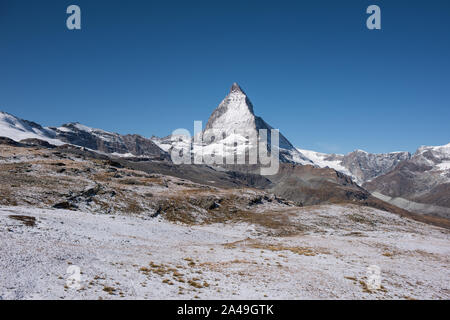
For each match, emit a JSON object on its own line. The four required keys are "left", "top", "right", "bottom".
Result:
{"left": 363, "top": 144, "right": 450, "bottom": 218}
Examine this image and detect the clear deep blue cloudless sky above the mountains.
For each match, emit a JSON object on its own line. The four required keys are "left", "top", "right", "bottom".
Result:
{"left": 0, "top": 0, "right": 450, "bottom": 153}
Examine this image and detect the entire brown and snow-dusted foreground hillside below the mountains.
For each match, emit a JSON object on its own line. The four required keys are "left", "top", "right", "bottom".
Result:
{"left": 0, "top": 139, "right": 450, "bottom": 299}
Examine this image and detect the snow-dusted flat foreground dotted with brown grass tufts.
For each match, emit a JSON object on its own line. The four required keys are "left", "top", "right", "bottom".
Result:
{"left": 0, "top": 205, "right": 450, "bottom": 299}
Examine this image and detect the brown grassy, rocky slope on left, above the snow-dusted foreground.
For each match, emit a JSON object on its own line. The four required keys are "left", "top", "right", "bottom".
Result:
{"left": 0, "top": 142, "right": 292, "bottom": 221}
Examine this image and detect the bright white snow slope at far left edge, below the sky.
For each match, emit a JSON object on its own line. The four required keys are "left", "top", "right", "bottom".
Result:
{"left": 0, "top": 111, "right": 63, "bottom": 145}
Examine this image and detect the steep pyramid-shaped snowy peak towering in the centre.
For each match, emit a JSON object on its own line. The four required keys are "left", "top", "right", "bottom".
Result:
{"left": 203, "top": 83, "right": 312, "bottom": 164}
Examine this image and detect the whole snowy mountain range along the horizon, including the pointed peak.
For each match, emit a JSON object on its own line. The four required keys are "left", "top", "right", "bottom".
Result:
{"left": 0, "top": 83, "right": 450, "bottom": 218}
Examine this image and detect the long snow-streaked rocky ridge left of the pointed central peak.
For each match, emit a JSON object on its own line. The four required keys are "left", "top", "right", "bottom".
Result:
{"left": 0, "top": 112, "right": 169, "bottom": 159}
